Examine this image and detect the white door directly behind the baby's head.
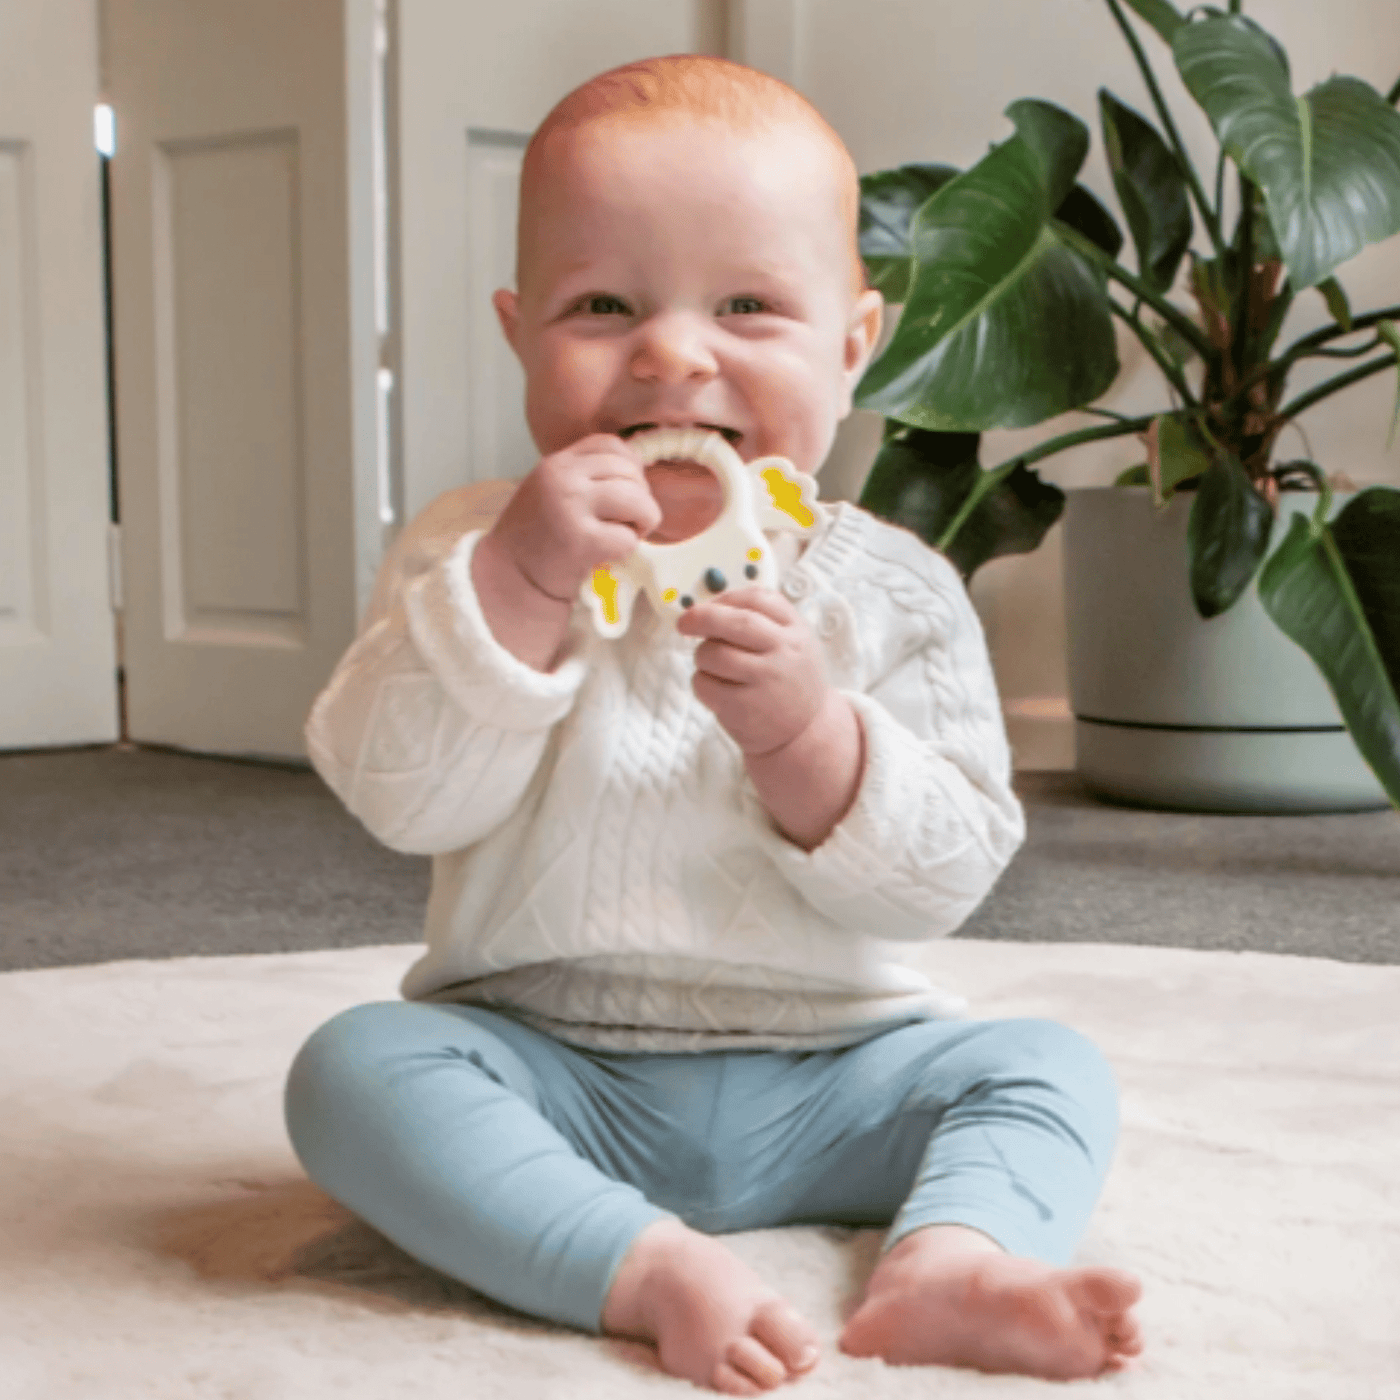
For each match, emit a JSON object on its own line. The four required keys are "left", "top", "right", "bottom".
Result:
{"left": 392, "top": 0, "right": 727, "bottom": 517}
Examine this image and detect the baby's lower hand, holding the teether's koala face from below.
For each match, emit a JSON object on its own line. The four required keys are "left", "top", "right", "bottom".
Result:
{"left": 676, "top": 585, "right": 832, "bottom": 757}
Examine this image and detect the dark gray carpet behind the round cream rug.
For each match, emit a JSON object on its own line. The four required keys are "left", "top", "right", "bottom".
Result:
{"left": 0, "top": 748, "right": 1400, "bottom": 970}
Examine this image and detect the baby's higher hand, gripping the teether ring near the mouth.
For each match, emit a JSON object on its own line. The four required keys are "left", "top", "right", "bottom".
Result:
{"left": 490, "top": 433, "right": 661, "bottom": 602}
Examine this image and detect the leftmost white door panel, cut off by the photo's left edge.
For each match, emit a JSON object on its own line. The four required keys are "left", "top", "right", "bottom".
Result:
{"left": 0, "top": 0, "right": 118, "bottom": 749}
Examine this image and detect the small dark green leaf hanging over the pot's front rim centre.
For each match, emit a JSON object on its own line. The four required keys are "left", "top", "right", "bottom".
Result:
{"left": 1186, "top": 452, "right": 1274, "bottom": 617}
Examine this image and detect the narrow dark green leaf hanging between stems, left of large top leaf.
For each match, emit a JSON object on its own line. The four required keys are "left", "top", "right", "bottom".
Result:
{"left": 1099, "top": 88, "right": 1191, "bottom": 291}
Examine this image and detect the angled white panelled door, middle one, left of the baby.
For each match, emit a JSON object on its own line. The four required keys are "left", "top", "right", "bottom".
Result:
{"left": 103, "top": 0, "right": 378, "bottom": 757}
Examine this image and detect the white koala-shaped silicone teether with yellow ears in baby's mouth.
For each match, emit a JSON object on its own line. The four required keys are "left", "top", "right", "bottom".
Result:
{"left": 580, "top": 428, "right": 819, "bottom": 637}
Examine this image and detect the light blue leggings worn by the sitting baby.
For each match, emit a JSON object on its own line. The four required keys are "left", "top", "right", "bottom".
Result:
{"left": 286, "top": 1001, "right": 1117, "bottom": 1331}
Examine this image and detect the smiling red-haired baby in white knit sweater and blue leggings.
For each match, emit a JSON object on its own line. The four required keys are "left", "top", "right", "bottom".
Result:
{"left": 287, "top": 56, "right": 1141, "bottom": 1394}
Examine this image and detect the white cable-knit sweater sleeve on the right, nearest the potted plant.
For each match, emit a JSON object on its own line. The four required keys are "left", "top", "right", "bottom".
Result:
{"left": 745, "top": 532, "right": 1025, "bottom": 941}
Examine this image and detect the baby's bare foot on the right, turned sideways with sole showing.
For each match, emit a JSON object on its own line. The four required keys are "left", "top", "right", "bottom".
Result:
{"left": 840, "top": 1225, "right": 1142, "bottom": 1380}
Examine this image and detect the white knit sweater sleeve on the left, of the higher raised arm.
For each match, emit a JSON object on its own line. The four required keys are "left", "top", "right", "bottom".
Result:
{"left": 305, "top": 498, "right": 585, "bottom": 855}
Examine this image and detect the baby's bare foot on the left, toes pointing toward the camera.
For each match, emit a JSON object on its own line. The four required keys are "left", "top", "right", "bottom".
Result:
{"left": 602, "top": 1219, "right": 819, "bottom": 1396}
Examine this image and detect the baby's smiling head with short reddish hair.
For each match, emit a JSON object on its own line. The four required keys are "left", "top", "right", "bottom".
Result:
{"left": 494, "top": 55, "right": 882, "bottom": 490}
